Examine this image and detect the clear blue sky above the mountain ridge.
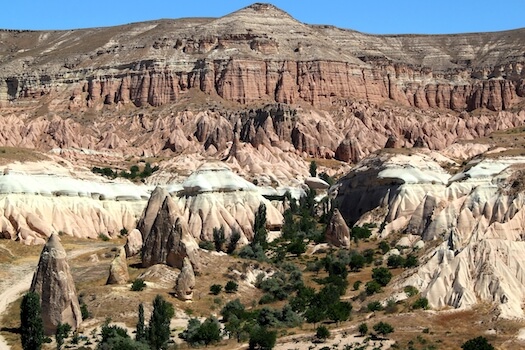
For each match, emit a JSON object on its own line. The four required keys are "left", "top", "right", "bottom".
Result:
{"left": 4, "top": 0, "right": 525, "bottom": 34}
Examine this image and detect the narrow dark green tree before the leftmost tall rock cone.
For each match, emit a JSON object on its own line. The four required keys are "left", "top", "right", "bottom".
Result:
{"left": 20, "top": 292, "right": 44, "bottom": 350}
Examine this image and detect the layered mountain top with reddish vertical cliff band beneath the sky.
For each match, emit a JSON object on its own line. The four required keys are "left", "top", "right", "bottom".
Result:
{"left": 0, "top": 4, "right": 525, "bottom": 111}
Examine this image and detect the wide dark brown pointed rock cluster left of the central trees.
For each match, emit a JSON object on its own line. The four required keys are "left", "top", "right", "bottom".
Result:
{"left": 142, "top": 196, "right": 200, "bottom": 273}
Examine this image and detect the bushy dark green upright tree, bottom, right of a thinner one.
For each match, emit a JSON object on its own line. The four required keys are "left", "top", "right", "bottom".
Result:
{"left": 148, "top": 295, "right": 175, "bottom": 350}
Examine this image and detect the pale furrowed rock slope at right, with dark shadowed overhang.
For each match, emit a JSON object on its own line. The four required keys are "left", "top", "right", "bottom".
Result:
{"left": 337, "top": 151, "right": 525, "bottom": 318}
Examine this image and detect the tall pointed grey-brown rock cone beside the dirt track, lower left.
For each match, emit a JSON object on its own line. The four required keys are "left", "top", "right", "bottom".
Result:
{"left": 30, "top": 234, "right": 82, "bottom": 335}
